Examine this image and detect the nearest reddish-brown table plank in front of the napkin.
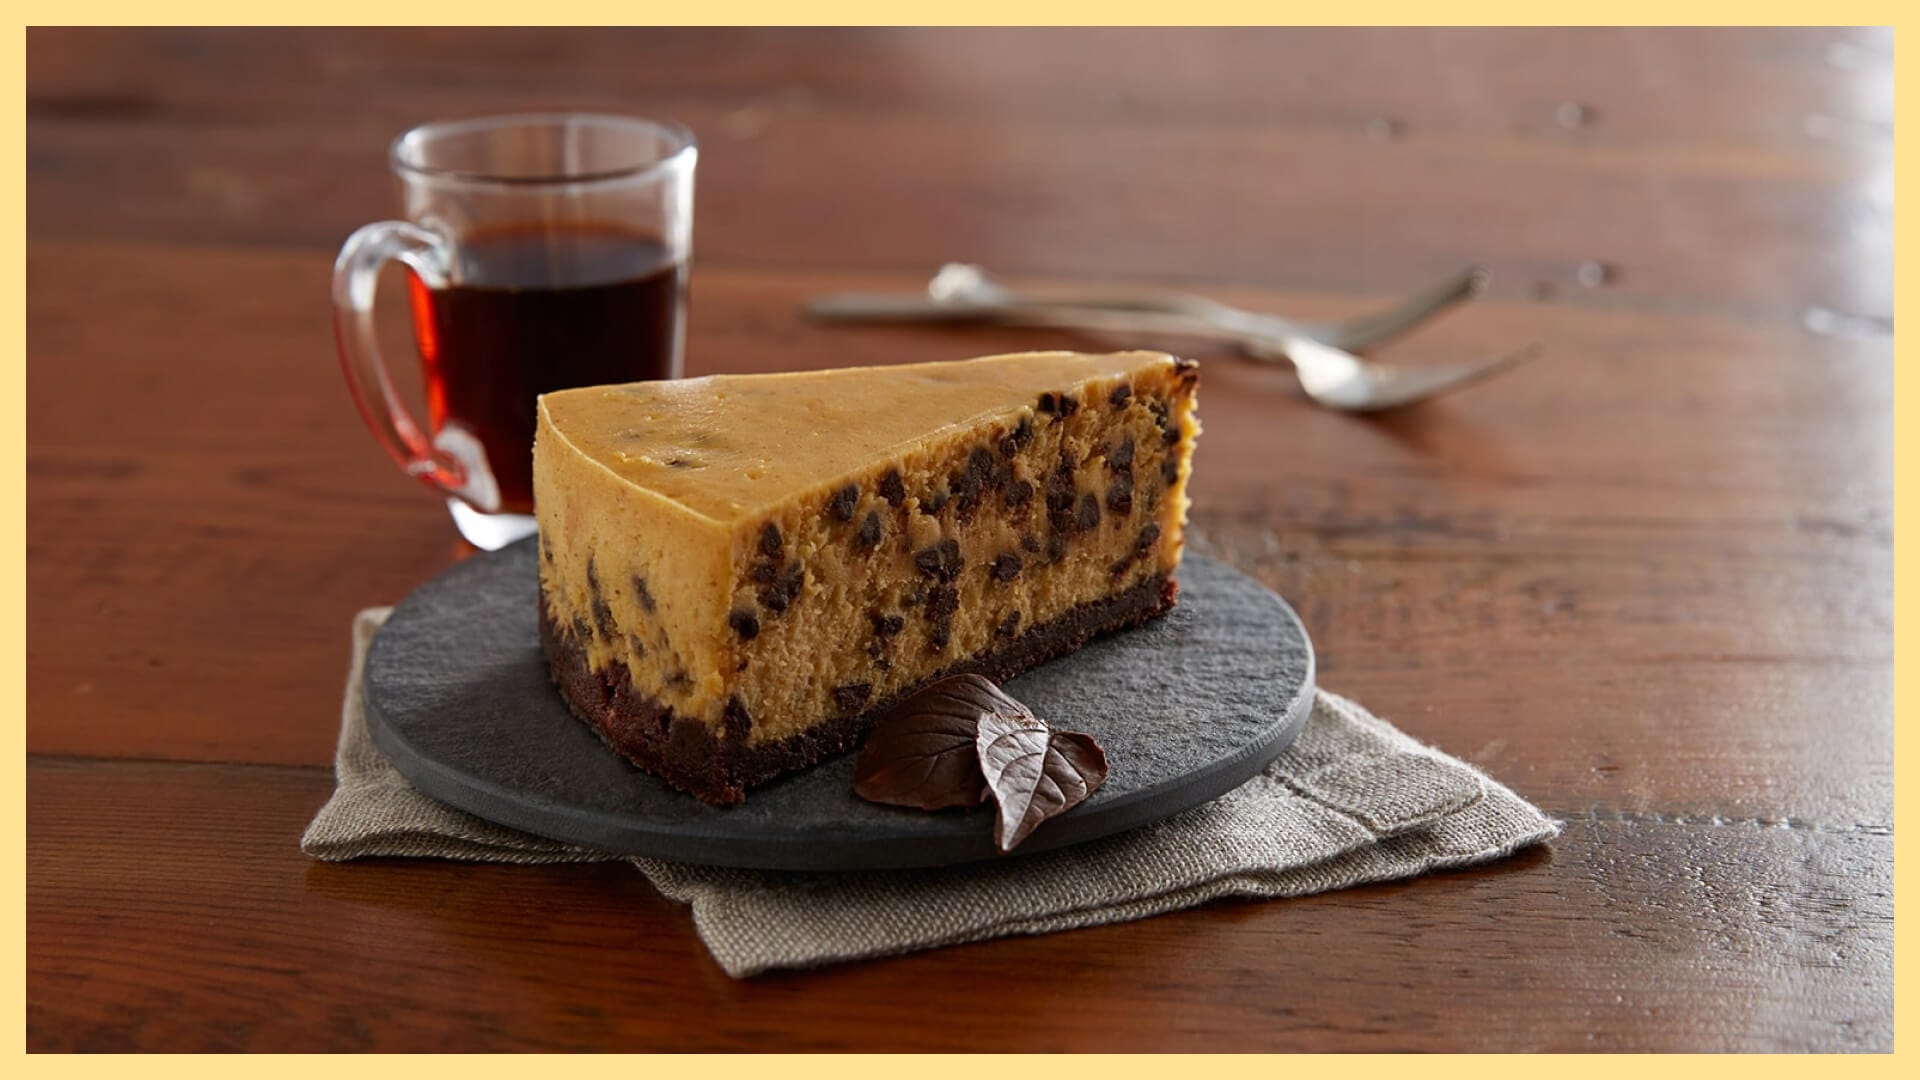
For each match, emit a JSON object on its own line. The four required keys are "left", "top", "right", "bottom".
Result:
{"left": 27, "top": 759, "right": 1893, "bottom": 1051}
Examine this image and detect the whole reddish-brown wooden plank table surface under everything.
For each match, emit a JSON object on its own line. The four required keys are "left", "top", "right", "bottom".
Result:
{"left": 27, "top": 31, "right": 1893, "bottom": 1049}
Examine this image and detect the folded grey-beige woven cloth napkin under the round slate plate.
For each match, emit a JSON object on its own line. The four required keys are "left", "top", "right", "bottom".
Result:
{"left": 300, "top": 607, "right": 1559, "bottom": 976}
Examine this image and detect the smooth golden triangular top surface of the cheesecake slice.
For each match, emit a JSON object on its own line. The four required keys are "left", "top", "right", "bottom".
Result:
{"left": 540, "top": 352, "right": 1175, "bottom": 521}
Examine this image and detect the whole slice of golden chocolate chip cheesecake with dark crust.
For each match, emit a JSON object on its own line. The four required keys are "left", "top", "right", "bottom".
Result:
{"left": 534, "top": 352, "right": 1200, "bottom": 803}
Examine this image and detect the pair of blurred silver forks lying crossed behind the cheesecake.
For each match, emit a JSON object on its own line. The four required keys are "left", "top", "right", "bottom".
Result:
{"left": 806, "top": 263, "right": 1538, "bottom": 413}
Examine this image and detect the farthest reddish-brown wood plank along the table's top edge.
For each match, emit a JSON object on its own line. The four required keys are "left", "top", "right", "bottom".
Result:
{"left": 29, "top": 27, "right": 1893, "bottom": 146}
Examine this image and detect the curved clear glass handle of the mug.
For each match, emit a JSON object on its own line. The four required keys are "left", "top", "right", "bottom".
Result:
{"left": 334, "top": 221, "right": 499, "bottom": 513}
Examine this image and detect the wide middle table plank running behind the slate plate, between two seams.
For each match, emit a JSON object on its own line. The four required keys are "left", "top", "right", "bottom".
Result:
{"left": 29, "top": 242, "right": 1891, "bottom": 821}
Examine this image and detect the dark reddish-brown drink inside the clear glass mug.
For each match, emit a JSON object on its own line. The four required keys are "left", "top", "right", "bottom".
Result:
{"left": 407, "top": 225, "right": 685, "bottom": 513}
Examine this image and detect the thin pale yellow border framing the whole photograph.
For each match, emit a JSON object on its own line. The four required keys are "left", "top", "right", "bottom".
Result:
{"left": 11, "top": 10, "right": 1920, "bottom": 1060}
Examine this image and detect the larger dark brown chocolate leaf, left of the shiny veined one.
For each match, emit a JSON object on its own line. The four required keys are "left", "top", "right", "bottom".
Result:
{"left": 852, "top": 675, "right": 1033, "bottom": 809}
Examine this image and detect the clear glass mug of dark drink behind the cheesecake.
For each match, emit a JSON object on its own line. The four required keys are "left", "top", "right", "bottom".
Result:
{"left": 334, "top": 113, "right": 697, "bottom": 550}
